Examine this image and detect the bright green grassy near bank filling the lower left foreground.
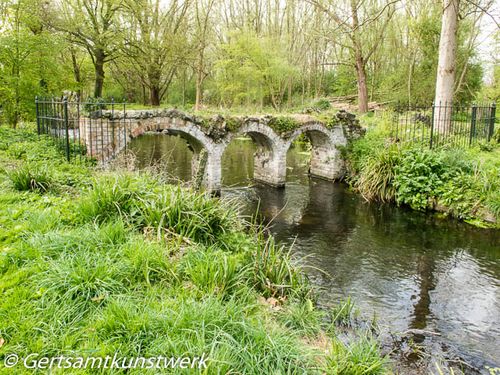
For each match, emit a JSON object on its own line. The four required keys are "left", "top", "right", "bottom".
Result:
{"left": 0, "top": 127, "right": 386, "bottom": 374}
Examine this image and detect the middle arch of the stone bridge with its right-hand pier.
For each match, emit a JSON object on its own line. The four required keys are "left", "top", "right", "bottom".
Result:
{"left": 223, "top": 119, "right": 286, "bottom": 187}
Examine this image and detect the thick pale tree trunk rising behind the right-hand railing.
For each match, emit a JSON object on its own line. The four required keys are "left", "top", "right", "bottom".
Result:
{"left": 434, "top": 0, "right": 459, "bottom": 133}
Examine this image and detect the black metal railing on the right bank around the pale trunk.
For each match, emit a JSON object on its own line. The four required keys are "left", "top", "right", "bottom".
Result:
{"left": 391, "top": 103, "right": 496, "bottom": 148}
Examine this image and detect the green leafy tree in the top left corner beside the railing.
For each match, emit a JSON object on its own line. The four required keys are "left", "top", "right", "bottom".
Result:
{"left": 0, "top": 0, "right": 66, "bottom": 127}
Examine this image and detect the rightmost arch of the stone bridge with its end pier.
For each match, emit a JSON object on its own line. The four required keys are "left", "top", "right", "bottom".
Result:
{"left": 285, "top": 122, "right": 347, "bottom": 180}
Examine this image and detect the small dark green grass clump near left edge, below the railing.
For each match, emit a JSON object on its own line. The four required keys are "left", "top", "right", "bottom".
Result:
{"left": 7, "top": 163, "right": 52, "bottom": 192}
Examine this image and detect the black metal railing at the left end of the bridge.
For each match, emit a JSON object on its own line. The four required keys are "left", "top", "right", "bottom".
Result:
{"left": 35, "top": 97, "right": 128, "bottom": 161}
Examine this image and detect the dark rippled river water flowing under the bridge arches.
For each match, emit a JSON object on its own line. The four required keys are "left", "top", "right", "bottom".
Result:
{"left": 131, "top": 135, "right": 500, "bottom": 367}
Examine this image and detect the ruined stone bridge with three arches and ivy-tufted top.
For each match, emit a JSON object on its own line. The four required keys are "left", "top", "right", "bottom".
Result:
{"left": 80, "top": 110, "right": 359, "bottom": 191}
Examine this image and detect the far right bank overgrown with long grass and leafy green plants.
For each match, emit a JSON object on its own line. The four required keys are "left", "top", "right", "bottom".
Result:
{"left": 346, "top": 117, "right": 500, "bottom": 227}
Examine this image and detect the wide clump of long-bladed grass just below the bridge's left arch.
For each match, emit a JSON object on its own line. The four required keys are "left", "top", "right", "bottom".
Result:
{"left": 78, "top": 174, "right": 237, "bottom": 244}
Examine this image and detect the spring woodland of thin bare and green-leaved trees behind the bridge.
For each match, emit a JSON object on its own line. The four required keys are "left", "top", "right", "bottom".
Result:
{"left": 0, "top": 0, "right": 500, "bottom": 126}
